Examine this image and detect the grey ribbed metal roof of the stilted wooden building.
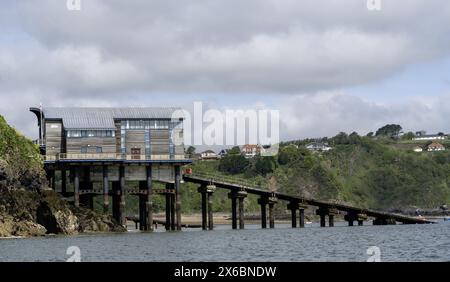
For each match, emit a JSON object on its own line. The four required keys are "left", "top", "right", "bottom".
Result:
{"left": 43, "top": 107, "right": 182, "bottom": 130}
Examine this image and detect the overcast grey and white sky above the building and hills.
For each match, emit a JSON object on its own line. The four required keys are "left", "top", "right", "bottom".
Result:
{"left": 0, "top": 0, "right": 450, "bottom": 143}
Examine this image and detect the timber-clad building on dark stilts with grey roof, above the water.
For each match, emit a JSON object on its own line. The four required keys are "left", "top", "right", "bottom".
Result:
{"left": 30, "top": 107, "right": 191, "bottom": 231}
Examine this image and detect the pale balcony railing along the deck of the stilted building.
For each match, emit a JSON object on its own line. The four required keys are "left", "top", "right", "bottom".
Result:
{"left": 44, "top": 153, "right": 189, "bottom": 161}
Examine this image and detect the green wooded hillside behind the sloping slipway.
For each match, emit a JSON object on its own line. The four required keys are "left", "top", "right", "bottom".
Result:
{"left": 186, "top": 135, "right": 450, "bottom": 213}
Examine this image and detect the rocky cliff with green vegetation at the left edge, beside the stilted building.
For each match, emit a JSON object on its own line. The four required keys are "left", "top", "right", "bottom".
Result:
{"left": 0, "top": 116, "right": 126, "bottom": 237}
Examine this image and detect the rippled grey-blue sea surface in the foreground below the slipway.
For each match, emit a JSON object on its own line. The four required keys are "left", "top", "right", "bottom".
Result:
{"left": 0, "top": 221, "right": 450, "bottom": 261}
